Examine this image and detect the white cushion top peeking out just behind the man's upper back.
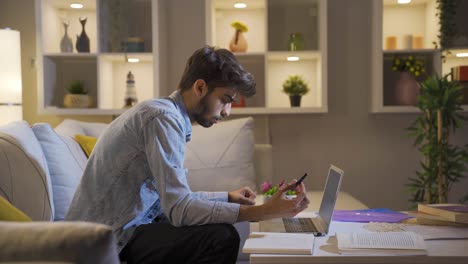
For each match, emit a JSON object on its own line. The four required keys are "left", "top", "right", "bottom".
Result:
{"left": 55, "top": 119, "right": 109, "bottom": 138}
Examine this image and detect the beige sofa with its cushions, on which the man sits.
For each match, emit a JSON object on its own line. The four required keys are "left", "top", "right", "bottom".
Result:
{"left": 0, "top": 118, "right": 272, "bottom": 263}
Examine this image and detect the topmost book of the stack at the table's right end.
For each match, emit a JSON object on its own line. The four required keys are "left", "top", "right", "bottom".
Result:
{"left": 418, "top": 204, "right": 468, "bottom": 223}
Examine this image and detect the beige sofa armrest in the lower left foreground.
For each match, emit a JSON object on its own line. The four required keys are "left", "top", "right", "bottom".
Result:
{"left": 0, "top": 222, "right": 119, "bottom": 264}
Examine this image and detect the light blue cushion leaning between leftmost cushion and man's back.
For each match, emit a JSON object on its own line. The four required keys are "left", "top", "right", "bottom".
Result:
{"left": 32, "top": 123, "right": 87, "bottom": 220}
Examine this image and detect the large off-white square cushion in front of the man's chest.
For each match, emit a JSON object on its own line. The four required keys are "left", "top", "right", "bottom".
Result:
{"left": 185, "top": 117, "right": 255, "bottom": 191}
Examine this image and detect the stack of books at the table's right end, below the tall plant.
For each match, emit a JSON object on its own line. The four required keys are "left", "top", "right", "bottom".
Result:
{"left": 408, "top": 204, "right": 468, "bottom": 227}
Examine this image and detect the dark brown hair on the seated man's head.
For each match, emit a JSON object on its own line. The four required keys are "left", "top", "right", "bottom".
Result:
{"left": 179, "top": 46, "right": 255, "bottom": 97}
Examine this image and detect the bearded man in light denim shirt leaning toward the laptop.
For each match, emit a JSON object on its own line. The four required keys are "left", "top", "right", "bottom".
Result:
{"left": 66, "top": 47, "right": 309, "bottom": 263}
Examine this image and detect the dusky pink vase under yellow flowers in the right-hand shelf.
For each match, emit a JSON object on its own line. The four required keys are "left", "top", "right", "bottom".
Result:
{"left": 394, "top": 72, "right": 419, "bottom": 106}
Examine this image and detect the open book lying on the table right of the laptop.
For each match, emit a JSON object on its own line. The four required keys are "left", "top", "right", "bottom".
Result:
{"left": 336, "top": 232, "right": 427, "bottom": 256}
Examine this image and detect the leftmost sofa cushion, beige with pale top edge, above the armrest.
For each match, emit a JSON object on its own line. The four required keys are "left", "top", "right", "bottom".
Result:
{"left": 0, "top": 121, "right": 54, "bottom": 221}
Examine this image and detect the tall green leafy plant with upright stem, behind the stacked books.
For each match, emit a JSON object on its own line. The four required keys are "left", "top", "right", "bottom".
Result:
{"left": 408, "top": 75, "right": 468, "bottom": 205}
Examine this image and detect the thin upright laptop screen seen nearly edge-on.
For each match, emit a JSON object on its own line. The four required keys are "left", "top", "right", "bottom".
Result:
{"left": 319, "top": 165, "right": 343, "bottom": 233}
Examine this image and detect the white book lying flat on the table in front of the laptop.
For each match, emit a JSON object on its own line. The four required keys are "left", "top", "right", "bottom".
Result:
{"left": 242, "top": 232, "right": 315, "bottom": 255}
